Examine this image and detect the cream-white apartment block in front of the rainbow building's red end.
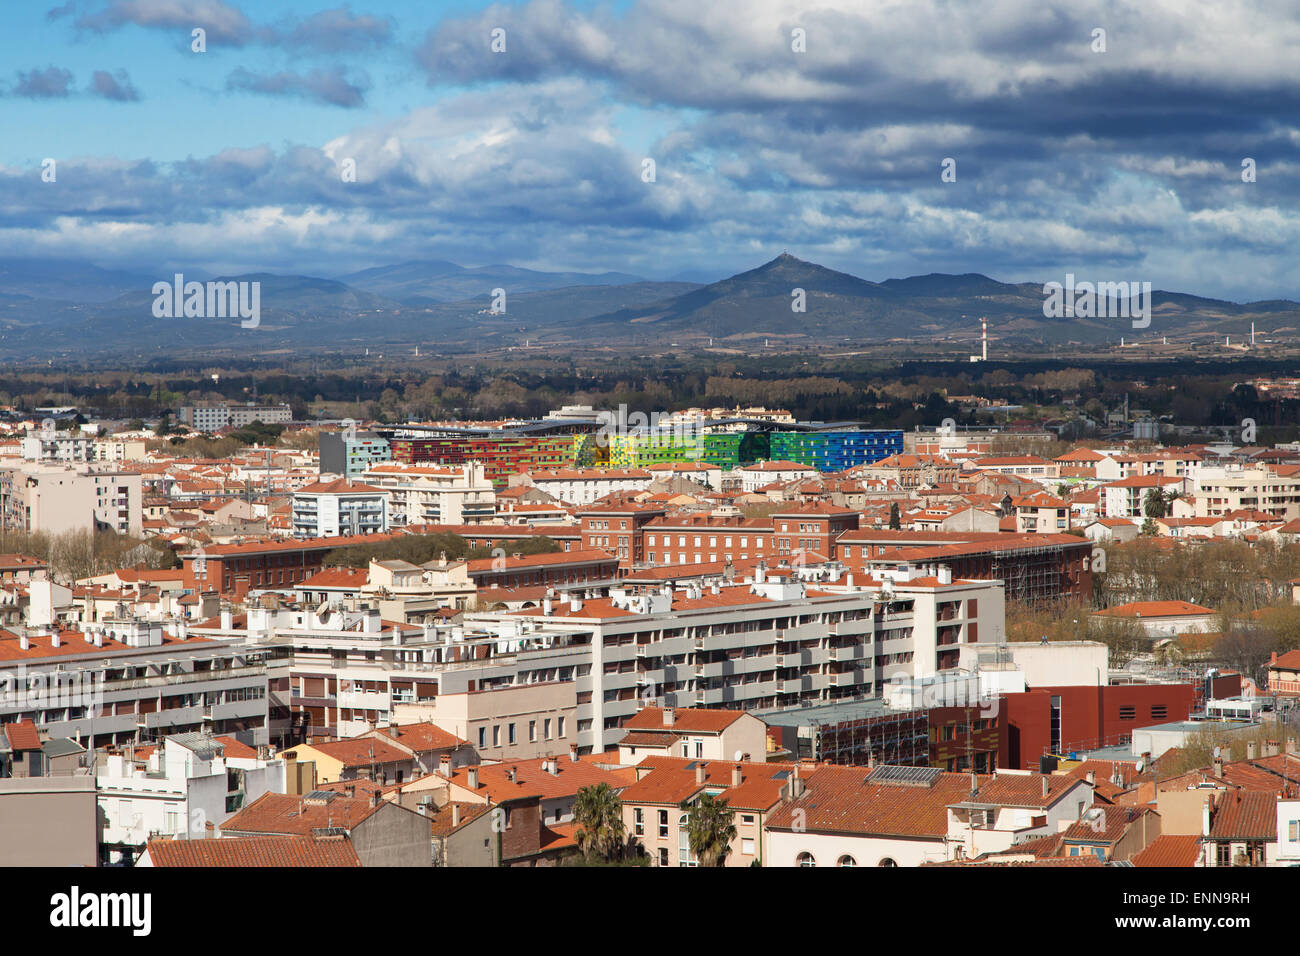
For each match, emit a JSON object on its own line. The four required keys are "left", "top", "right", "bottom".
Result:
{"left": 361, "top": 462, "right": 497, "bottom": 525}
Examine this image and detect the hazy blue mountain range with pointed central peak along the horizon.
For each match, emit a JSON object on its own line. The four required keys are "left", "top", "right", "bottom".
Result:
{"left": 0, "top": 254, "right": 1300, "bottom": 358}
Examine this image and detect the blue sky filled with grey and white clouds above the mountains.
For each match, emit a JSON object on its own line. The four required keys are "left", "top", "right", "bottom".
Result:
{"left": 0, "top": 0, "right": 1300, "bottom": 300}
